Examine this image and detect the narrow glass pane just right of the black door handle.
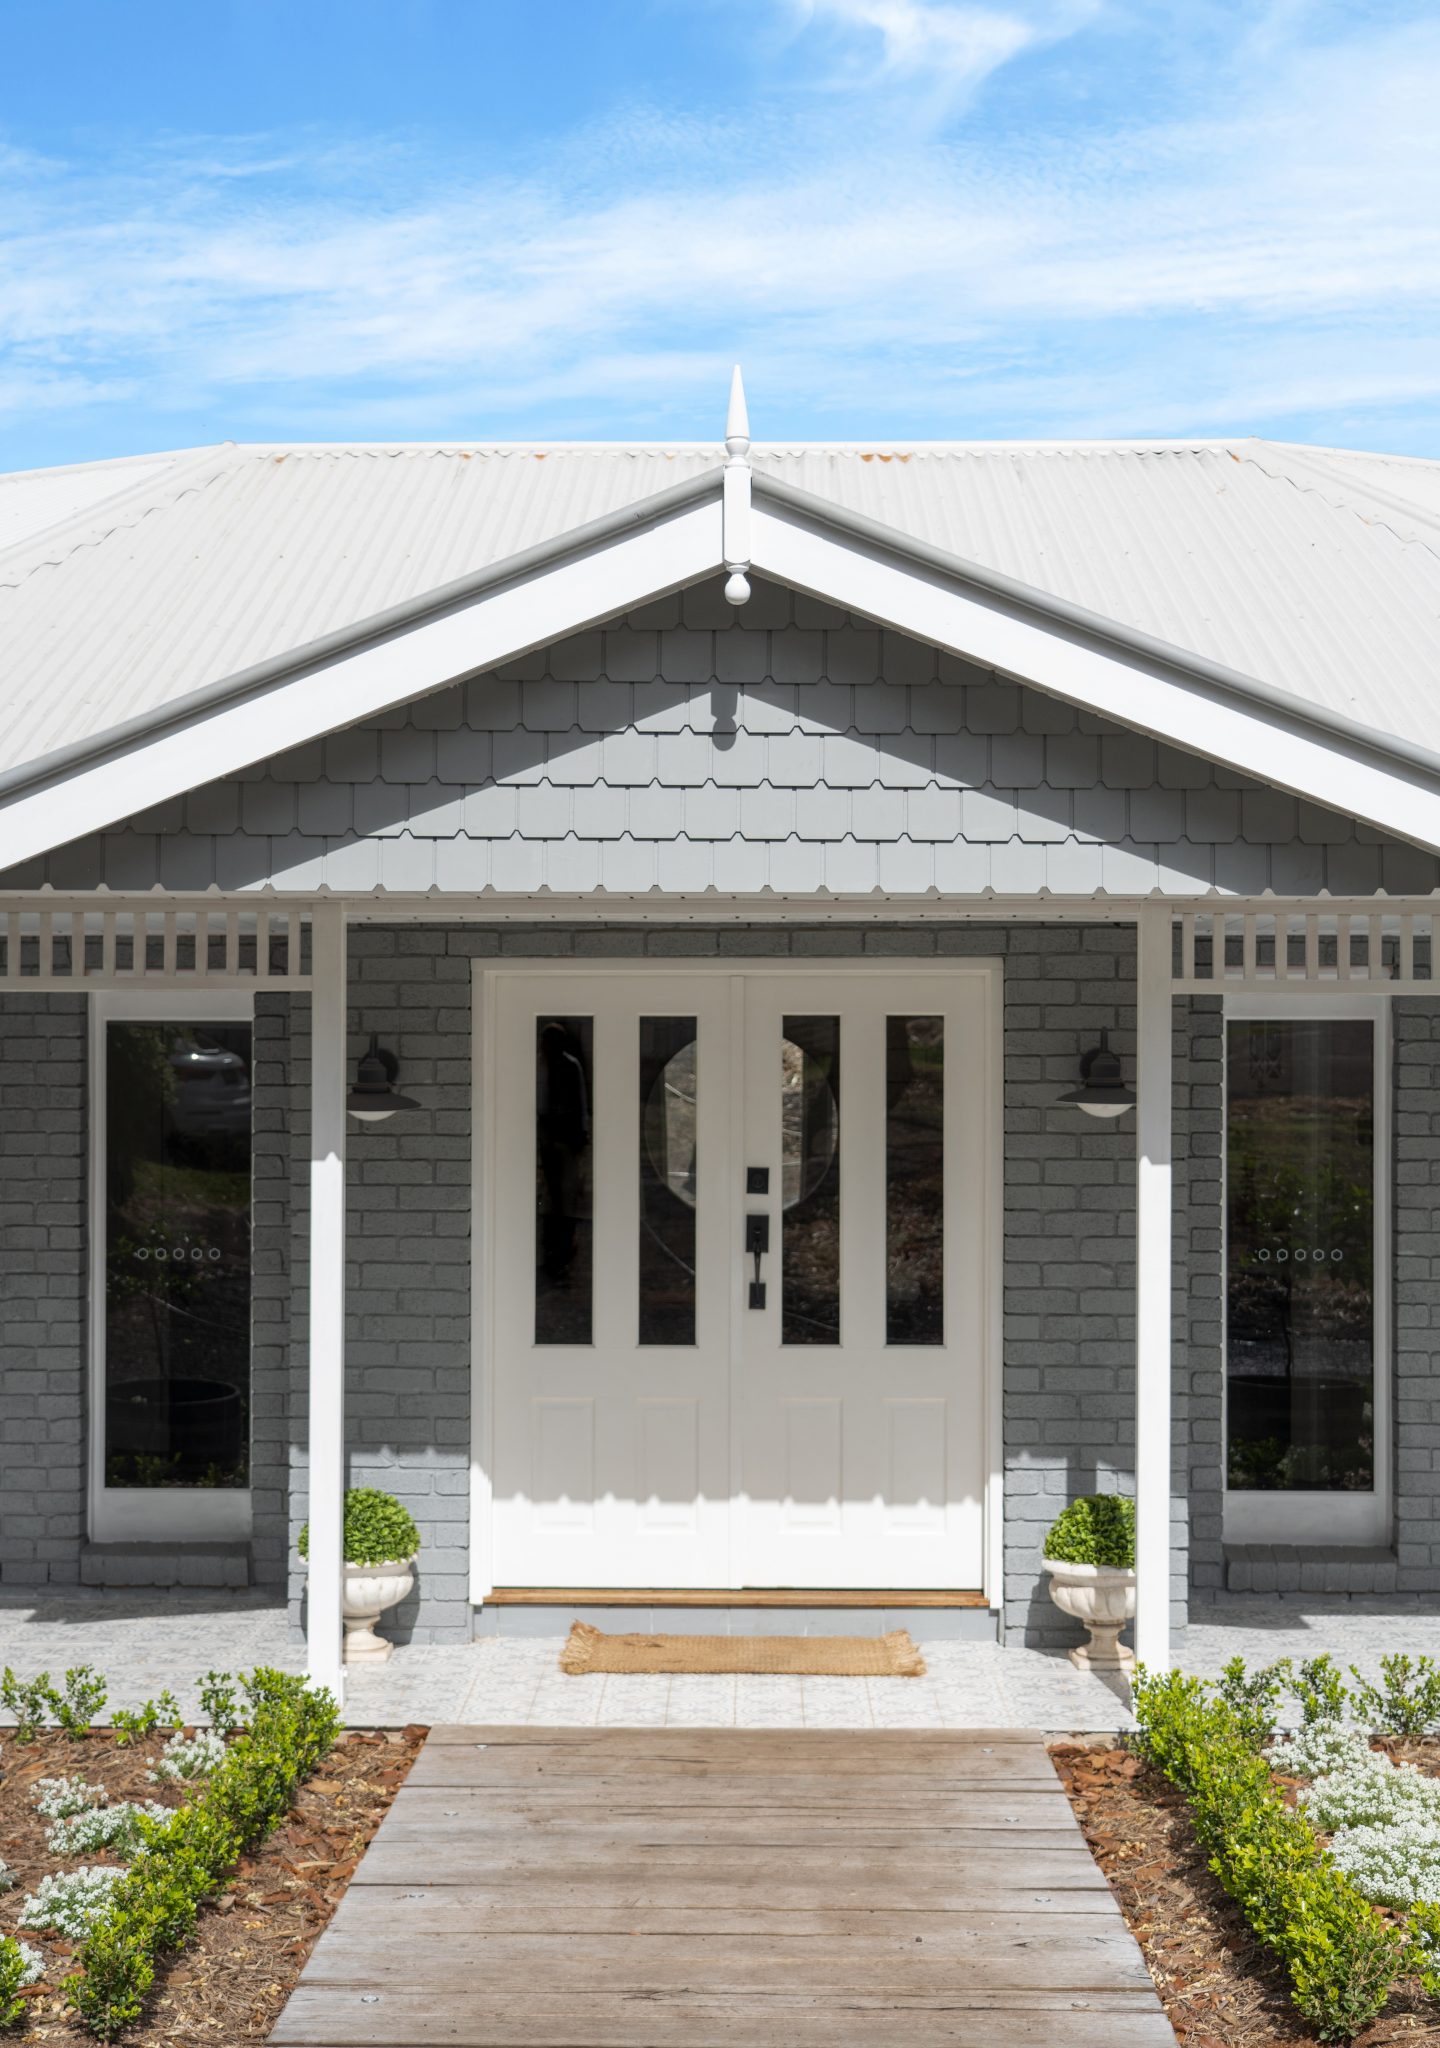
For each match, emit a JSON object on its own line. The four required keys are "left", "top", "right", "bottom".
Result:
{"left": 780, "top": 1018, "right": 840, "bottom": 1343}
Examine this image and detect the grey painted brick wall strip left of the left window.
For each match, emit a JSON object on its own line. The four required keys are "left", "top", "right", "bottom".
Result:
{"left": 0, "top": 991, "right": 86, "bottom": 1585}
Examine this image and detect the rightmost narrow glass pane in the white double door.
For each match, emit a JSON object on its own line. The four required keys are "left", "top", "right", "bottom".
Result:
{"left": 885, "top": 1018, "right": 944, "bottom": 1343}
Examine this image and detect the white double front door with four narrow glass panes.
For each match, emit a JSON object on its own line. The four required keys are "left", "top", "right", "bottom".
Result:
{"left": 479, "top": 963, "right": 1000, "bottom": 1589}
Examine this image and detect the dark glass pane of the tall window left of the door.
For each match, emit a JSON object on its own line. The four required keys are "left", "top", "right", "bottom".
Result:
{"left": 104, "top": 1024, "right": 250, "bottom": 1487}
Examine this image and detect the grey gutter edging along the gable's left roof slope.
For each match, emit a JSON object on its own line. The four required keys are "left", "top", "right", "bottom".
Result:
{"left": 0, "top": 467, "right": 723, "bottom": 801}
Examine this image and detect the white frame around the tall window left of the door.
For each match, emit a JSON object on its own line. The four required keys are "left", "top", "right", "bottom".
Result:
{"left": 86, "top": 989, "right": 254, "bottom": 1544}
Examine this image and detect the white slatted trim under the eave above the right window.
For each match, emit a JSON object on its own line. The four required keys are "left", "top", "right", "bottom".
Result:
{"left": 1172, "top": 903, "right": 1440, "bottom": 995}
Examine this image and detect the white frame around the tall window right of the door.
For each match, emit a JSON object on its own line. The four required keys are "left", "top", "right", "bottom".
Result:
{"left": 1221, "top": 989, "right": 1395, "bottom": 1548}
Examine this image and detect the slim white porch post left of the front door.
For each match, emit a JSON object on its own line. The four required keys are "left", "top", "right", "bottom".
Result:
{"left": 307, "top": 903, "right": 346, "bottom": 1700}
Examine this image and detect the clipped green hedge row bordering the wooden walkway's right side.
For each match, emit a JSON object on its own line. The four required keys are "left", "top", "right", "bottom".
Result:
{"left": 1135, "top": 1669, "right": 1415, "bottom": 2042}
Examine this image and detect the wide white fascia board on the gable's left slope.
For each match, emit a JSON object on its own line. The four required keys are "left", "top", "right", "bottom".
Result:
{"left": 0, "top": 503, "right": 723, "bottom": 870}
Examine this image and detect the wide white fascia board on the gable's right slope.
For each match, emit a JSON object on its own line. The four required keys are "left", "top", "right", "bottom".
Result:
{"left": 750, "top": 494, "right": 1440, "bottom": 852}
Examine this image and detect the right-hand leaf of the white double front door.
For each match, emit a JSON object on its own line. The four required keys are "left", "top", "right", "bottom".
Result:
{"left": 735, "top": 973, "right": 987, "bottom": 1589}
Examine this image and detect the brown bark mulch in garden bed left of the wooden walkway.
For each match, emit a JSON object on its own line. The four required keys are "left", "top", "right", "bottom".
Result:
{"left": 0, "top": 1726, "right": 428, "bottom": 2048}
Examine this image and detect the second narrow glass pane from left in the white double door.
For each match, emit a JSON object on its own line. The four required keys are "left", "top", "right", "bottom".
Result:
{"left": 639, "top": 1018, "right": 696, "bottom": 1343}
